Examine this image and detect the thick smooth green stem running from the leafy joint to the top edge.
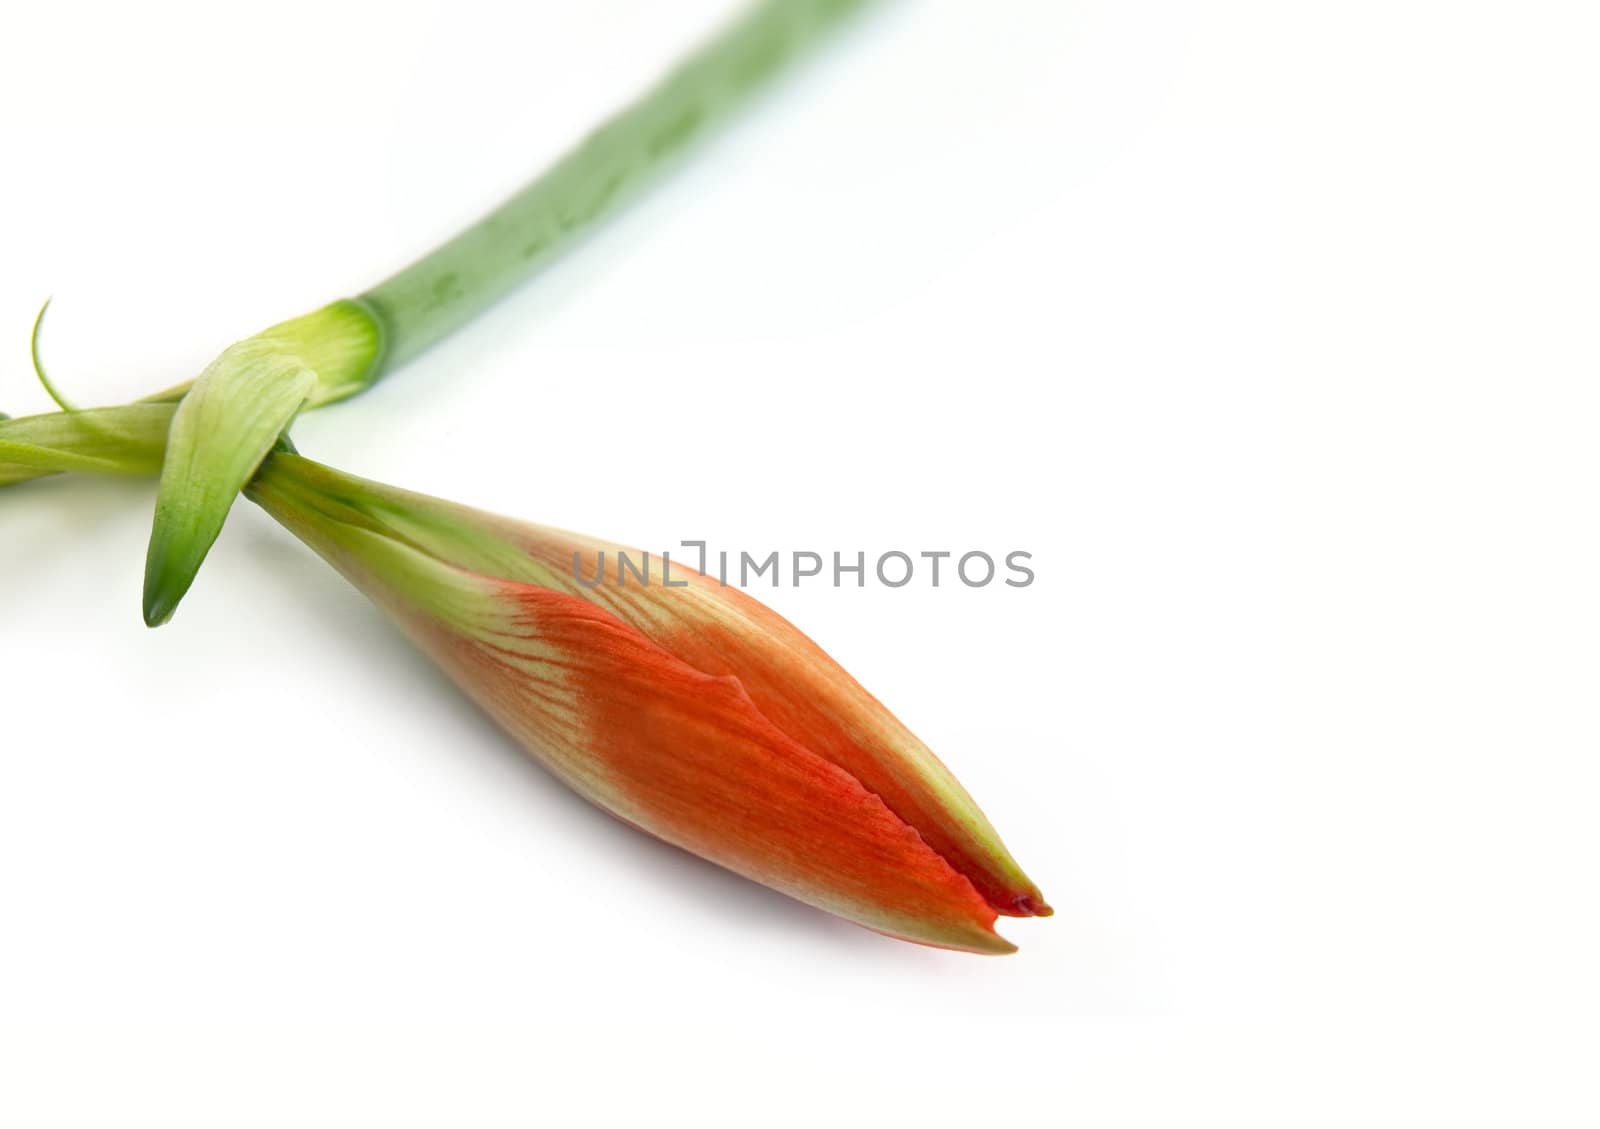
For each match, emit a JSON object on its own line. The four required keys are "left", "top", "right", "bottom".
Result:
{"left": 357, "top": 0, "right": 869, "bottom": 369}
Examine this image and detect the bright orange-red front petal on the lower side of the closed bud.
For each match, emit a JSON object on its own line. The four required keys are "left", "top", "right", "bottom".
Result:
{"left": 411, "top": 582, "right": 1014, "bottom": 953}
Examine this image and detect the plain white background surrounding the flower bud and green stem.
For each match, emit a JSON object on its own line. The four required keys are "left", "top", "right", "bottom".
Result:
{"left": 0, "top": 0, "right": 1600, "bottom": 1126}
